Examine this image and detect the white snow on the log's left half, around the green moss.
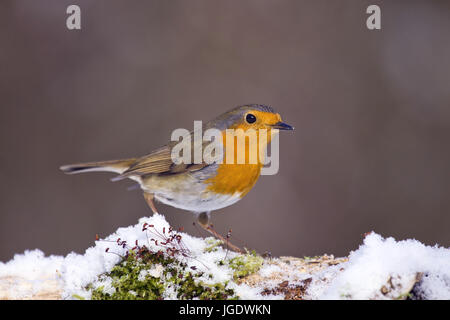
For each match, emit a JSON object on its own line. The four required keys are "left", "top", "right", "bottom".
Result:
{"left": 0, "top": 214, "right": 259, "bottom": 299}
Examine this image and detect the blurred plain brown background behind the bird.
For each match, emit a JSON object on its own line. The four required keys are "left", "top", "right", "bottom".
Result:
{"left": 0, "top": 0, "right": 450, "bottom": 261}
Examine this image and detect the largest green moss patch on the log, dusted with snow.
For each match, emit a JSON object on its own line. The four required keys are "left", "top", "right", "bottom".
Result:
{"left": 87, "top": 247, "right": 237, "bottom": 300}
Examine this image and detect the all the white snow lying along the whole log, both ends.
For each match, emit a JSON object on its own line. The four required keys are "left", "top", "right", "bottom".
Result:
{"left": 0, "top": 214, "right": 450, "bottom": 299}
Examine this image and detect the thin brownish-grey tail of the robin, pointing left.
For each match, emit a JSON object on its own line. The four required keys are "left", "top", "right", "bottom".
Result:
{"left": 60, "top": 158, "right": 136, "bottom": 174}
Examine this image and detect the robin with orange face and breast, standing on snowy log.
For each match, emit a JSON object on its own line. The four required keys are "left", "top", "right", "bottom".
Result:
{"left": 60, "top": 104, "right": 294, "bottom": 251}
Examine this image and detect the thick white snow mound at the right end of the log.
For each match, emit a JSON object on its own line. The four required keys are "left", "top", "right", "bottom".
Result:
{"left": 310, "top": 233, "right": 450, "bottom": 300}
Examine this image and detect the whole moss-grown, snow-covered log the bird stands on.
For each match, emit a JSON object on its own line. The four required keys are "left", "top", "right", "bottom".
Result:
{"left": 0, "top": 215, "right": 450, "bottom": 299}
